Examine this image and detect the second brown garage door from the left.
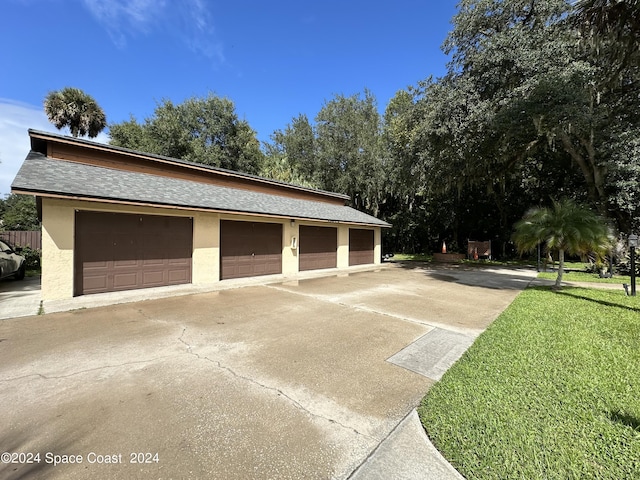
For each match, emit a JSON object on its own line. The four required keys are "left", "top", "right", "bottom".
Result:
{"left": 220, "top": 220, "right": 282, "bottom": 280}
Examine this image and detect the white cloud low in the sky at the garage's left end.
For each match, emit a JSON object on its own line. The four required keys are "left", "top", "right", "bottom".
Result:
{"left": 0, "top": 98, "right": 109, "bottom": 197}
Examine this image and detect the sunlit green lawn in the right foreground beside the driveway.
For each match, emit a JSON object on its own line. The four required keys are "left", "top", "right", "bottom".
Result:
{"left": 419, "top": 288, "right": 640, "bottom": 480}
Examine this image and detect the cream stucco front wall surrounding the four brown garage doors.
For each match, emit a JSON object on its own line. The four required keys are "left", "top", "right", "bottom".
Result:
{"left": 42, "top": 198, "right": 381, "bottom": 300}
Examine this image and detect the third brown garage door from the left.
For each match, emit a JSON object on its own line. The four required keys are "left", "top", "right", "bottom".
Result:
{"left": 299, "top": 225, "right": 338, "bottom": 271}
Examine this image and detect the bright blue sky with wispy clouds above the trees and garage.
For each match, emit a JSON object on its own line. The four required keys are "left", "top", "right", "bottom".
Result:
{"left": 0, "top": 0, "right": 457, "bottom": 195}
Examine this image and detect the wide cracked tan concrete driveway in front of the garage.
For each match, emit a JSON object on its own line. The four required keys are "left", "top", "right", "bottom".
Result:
{"left": 0, "top": 265, "right": 535, "bottom": 479}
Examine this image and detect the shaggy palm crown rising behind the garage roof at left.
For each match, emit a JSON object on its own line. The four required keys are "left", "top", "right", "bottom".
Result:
{"left": 44, "top": 87, "right": 107, "bottom": 138}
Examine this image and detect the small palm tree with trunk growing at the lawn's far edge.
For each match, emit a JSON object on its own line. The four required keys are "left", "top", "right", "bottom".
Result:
{"left": 513, "top": 199, "right": 613, "bottom": 289}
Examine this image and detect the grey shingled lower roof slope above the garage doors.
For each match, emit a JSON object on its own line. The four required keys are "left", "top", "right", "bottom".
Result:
{"left": 11, "top": 150, "right": 390, "bottom": 227}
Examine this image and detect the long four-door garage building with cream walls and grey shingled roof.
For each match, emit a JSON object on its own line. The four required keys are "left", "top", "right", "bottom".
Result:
{"left": 12, "top": 130, "right": 390, "bottom": 300}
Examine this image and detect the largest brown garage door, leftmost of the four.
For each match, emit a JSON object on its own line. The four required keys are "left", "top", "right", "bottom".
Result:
{"left": 75, "top": 212, "right": 193, "bottom": 295}
